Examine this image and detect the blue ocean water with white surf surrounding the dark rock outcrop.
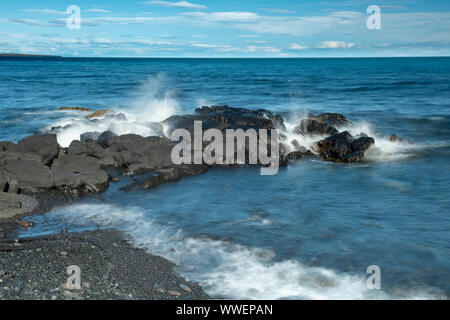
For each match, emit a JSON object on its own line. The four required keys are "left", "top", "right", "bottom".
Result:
{"left": 0, "top": 58, "right": 450, "bottom": 299}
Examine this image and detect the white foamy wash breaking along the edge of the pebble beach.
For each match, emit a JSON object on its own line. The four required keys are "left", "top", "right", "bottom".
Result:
{"left": 31, "top": 204, "right": 440, "bottom": 299}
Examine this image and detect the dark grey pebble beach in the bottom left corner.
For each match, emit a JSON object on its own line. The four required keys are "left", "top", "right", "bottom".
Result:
{"left": 0, "top": 230, "right": 209, "bottom": 300}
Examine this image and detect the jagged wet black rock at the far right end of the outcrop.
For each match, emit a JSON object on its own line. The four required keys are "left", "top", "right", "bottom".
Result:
{"left": 318, "top": 131, "right": 375, "bottom": 162}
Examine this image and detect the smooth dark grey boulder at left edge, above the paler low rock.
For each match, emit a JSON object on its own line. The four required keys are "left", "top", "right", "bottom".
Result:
{"left": 0, "top": 160, "right": 53, "bottom": 192}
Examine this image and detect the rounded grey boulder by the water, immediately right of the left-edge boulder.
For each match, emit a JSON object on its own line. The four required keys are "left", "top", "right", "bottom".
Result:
{"left": 51, "top": 154, "right": 108, "bottom": 193}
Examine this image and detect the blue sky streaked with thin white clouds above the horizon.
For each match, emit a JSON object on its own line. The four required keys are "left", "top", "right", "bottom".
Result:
{"left": 0, "top": 0, "right": 450, "bottom": 57}
